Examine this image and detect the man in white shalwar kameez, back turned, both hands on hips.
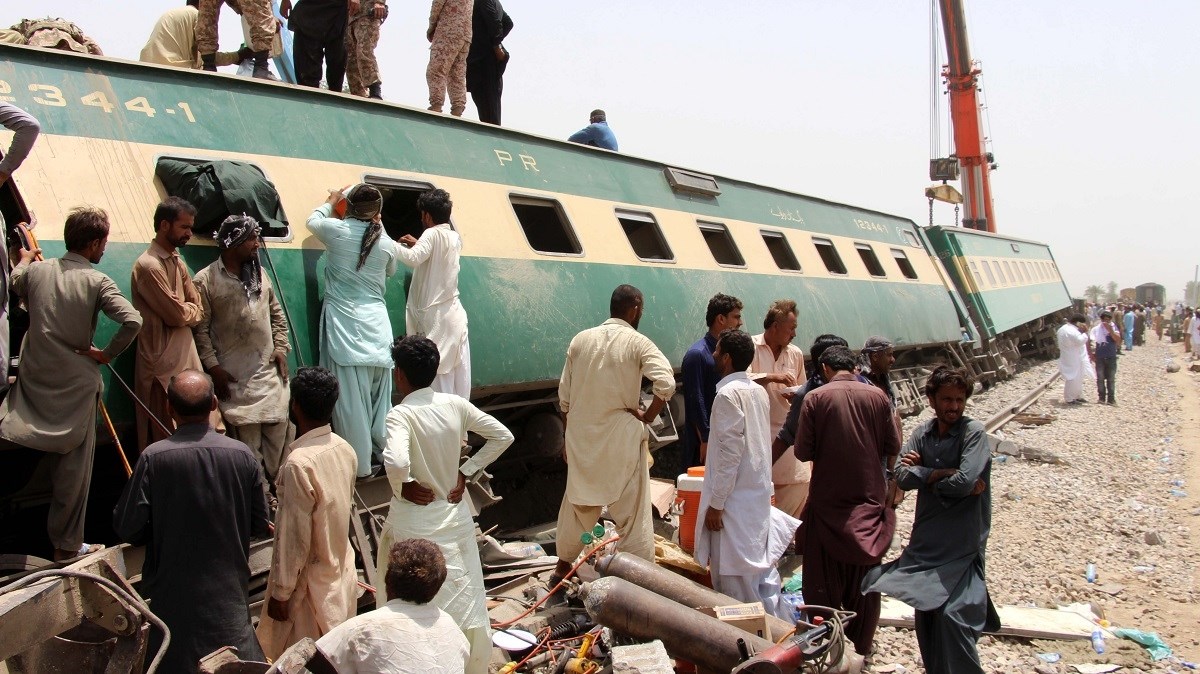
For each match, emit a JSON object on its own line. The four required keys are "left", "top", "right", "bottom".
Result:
{"left": 377, "top": 335, "right": 512, "bottom": 674}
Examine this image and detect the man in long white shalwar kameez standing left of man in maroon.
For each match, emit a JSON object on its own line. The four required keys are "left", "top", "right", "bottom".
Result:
{"left": 696, "top": 330, "right": 799, "bottom": 620}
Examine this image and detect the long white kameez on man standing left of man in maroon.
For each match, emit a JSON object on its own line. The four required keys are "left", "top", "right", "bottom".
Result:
{"left": 696, "top": 372, "right": 773, "bottom": 578}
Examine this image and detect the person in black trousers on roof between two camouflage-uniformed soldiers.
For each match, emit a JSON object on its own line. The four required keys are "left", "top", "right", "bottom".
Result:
{"left": 280, "top": 0, "right": 359, "bottom": 91}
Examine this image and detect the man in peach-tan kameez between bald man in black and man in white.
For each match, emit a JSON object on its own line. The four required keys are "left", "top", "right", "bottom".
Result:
{"left": 258, "top": 367, "right": 359, "bottom": 660}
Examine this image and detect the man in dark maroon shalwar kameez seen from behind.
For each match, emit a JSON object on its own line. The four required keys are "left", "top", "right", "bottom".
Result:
{"left": 796, "top": 347, "right": 900, "bottom": 656}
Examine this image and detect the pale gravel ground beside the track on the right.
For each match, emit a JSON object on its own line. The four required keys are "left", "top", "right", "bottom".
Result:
{"left": 874, "top": 335, "right": 1200, "bottom": 673}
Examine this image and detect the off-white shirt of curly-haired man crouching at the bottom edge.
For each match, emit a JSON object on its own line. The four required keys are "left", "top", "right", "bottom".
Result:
{"left": 317, "top": 600, "right": 468, "bottom": 674}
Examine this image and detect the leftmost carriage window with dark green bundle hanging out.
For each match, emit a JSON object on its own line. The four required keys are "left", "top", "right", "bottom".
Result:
{"left": 155, "top": 157, "right": 292, "bottom": 241}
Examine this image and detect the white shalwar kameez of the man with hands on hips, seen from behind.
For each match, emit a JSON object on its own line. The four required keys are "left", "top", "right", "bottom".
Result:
{"left": 379, "top": 389, "right": 512, "bottom": 630}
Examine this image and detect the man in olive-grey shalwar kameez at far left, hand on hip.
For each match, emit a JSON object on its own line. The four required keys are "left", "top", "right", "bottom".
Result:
{"left": 0, "top": 209, "right": 142, "bottom": 560}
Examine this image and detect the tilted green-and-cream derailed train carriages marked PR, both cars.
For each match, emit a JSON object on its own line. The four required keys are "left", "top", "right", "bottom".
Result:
{"left": 0, "top": 46, "right": 1070, "bottom": 547}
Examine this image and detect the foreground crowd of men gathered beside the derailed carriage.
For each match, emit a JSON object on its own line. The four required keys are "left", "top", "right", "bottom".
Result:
{"left": 0, "top": 97, "right": 994, "bottom": 674}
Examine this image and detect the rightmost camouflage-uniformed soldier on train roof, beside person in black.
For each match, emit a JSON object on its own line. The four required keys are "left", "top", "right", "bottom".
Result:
{"left": 425, "top": 0, "right": 474, "bottom": 118}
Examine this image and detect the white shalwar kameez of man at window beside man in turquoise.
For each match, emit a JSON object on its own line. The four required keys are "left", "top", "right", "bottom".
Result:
{"left": 396, "top": 224, "right": 470, "bottom": 378}
